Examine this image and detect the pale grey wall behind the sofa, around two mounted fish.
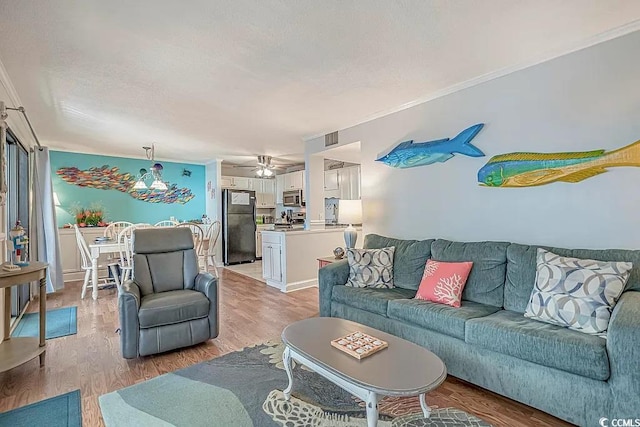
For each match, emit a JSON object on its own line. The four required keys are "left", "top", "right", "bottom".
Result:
{"left": 306, "top": 32, "right": 640, "bottom": 248}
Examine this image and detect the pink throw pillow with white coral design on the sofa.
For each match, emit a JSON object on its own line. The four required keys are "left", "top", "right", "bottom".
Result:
{"left": 416, "top": 259, "right": 473, "bottom": 307}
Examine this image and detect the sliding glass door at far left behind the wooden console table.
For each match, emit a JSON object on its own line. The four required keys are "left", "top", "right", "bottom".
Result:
{"left": 7, "top": 129, "right": 29, "bottom": 317}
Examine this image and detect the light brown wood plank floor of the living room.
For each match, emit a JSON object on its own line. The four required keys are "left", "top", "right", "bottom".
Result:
{"left": 0, "top": 269, "right": 569, "bottom": 427}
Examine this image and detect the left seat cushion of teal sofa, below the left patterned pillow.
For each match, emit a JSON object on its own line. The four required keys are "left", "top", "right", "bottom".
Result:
{"left": 331, "top": 285, "right": 416, "bottom": 316}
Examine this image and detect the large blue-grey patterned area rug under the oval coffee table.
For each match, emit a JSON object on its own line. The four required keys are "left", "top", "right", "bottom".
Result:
{"left": 100, "top": 341, "right": 489, "bottom": 427}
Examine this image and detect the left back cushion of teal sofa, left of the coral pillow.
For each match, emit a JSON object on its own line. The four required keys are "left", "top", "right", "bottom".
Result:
{"left": 364, "top": 234, "right": 434, "bottom": 290}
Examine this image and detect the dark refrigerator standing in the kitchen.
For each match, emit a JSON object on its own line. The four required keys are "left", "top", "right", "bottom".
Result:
{"left": 222, "top": 189, "right": 256, "bottom": 265}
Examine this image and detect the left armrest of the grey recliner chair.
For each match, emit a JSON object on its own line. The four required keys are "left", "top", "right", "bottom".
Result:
{"left": 118, "top": 280, "right": 140, "bottom": 359}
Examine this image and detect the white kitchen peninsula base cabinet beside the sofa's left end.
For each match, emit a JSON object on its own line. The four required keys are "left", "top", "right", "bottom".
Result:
{"left": 262, "top": 227, "right": 361, "bottom": 292}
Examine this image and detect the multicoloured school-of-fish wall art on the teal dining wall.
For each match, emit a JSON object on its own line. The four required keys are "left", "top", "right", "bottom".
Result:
{"left": 56, "top": 165, "right": 195, "bottom": 205}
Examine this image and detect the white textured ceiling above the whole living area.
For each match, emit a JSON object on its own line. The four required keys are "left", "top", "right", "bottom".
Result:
{"left": 0, "top": 0, "right": 640, "bottom": 163}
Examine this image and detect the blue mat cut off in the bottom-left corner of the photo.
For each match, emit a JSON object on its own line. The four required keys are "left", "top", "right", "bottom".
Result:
{"left": 0, "top": 390, "right": 82, "bottom": 427}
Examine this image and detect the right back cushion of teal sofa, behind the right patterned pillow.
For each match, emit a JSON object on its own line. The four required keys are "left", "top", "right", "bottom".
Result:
{"left": 508, "top": 243, "right": 640, "bottom": 313}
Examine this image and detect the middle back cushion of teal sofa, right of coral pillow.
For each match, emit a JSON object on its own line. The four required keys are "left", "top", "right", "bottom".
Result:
{"left": 431, "top": 240, "right": 510, "bottom": 308}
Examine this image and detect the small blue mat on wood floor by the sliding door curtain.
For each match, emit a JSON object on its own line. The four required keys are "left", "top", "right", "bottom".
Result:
{"left": 11, "top": 306, "right": 78, "bottom": 340}
